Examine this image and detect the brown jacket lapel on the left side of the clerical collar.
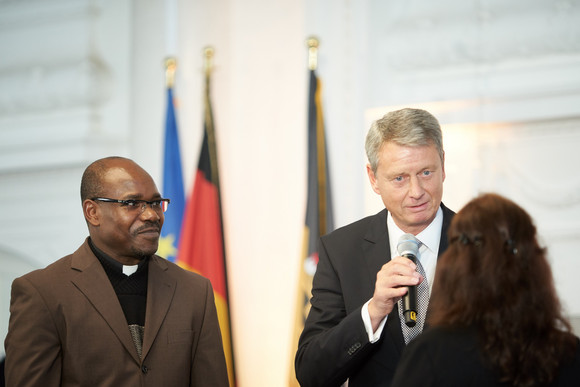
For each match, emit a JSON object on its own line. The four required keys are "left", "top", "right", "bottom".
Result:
{"left": 71, "top": 241, "right": 140, "bottom": 363}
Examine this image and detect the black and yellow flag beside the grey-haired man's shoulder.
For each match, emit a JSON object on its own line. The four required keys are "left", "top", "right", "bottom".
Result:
{"left": 289, "top": 41, "right": 334, "bottom": 386}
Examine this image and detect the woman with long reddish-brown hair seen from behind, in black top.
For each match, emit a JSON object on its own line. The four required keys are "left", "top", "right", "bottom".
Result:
{"left": 392, "top": 194, "right": 580, "bottom": 387}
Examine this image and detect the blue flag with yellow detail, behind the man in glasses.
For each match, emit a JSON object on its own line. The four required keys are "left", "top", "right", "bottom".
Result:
{"left": 157, "top": 87, "right": 185, "bottom": 262}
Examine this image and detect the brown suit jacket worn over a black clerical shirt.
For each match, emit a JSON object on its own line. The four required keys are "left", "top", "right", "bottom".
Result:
{"left": 5, "top": 241, "right": 228, "bottom": 387}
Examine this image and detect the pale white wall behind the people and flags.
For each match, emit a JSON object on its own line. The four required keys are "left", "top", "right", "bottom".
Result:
{"left": 0, "top": 0, "right": 580, "bottom": 387}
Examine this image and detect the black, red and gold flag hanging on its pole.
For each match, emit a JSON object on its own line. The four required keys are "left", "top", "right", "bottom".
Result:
{"left": 177, "top": 49, "right": 235, "bottom": 387}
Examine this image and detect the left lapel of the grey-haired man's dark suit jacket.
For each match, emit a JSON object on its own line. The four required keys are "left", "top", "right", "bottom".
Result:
{"left": 363, "top": 209, "right": 405, "bottom": 352}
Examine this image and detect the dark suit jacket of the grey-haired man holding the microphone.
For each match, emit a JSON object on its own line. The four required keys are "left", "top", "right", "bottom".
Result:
{"left": 296, "top": 204, "right": 454, "bottom": 387}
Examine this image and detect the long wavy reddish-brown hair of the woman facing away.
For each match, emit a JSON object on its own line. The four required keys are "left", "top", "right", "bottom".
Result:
{"left": 428, "top": 194, "right": 576, "bottom": 386}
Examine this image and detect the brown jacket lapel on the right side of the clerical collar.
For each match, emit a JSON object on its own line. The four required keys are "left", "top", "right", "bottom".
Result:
{"left": 143, "top": 256, "right": 176, "bottom": 359}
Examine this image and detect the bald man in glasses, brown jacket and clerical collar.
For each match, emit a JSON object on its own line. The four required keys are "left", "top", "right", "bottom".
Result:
{"left": 5, "top": 157, "right": 228, "bottom": 387}
